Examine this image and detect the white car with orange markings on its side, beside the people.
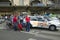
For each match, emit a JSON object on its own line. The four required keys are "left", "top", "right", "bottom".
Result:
{"left": 27, "top": 16, "right": 60, "bottom": 30}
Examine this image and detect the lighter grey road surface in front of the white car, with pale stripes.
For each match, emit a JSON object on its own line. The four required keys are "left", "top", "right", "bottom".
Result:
{"left": 20, "top": 29, "right": 60, "bottom": 40}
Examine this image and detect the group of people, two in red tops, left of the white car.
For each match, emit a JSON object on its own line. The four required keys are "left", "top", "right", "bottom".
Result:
{"left": 7, "top": 13, "right": 30, "bottom": 32}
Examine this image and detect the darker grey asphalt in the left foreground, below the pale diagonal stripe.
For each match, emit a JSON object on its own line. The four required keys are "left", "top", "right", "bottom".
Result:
{"left": 0, "top": 30, "right": 51, "bottom": 40}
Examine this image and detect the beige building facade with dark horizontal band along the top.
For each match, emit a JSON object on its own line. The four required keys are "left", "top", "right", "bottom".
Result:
{"left": 0, "top": 0, "right": 60, "bottom": 14}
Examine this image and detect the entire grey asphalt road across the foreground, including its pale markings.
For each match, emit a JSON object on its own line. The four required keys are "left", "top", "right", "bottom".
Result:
{"left": 0, "top": 23, "right": 60, "bottom": 40}
